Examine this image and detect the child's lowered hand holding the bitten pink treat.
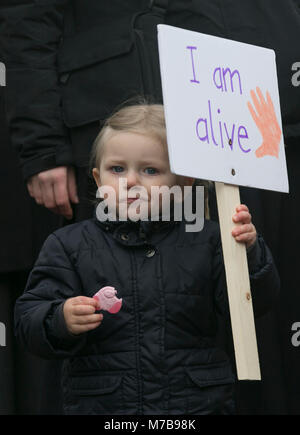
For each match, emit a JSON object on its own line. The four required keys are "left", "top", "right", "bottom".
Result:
{"left": 63, "top": 296, "right": 103, "bottom": 335}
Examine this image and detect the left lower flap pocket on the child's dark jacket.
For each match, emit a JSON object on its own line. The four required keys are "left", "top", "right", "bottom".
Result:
{"left": 65, "top": 375, "right": 124, "bottom": 415}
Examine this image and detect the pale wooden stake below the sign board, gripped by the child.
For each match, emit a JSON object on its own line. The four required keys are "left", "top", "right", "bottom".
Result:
{"left": 215, "top": 182, "right": 261, "bottom": 380}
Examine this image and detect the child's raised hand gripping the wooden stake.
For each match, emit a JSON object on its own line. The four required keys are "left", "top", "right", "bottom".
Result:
{"left": 231, "top": 204, "right": 256, "bottom": 248}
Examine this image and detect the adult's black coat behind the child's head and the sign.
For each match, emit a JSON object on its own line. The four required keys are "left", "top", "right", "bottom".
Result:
{"left": 0, "top": 0, "right": 300, "bottom": 178}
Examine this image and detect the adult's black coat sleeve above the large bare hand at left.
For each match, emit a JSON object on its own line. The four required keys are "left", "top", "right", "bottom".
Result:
{"left": 0, "top": 0, "right": 72, "bottom": 180}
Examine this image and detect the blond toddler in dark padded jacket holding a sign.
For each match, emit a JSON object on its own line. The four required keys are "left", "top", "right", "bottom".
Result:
{"left": 15, "top": 105, "right": 279, "bottom": 415}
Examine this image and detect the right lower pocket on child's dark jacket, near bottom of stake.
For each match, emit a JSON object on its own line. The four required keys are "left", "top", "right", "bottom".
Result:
{"left": 185, "top": 362, "right": 235, "bottom": 415}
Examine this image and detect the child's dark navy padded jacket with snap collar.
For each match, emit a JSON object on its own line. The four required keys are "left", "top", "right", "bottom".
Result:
{"left": 15, "top": 218, "right": 279, "bottom": 415}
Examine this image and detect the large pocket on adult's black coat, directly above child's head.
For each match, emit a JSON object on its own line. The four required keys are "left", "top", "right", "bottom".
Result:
{"left": 58, "top": 11, "right": 162, "bottom": 128}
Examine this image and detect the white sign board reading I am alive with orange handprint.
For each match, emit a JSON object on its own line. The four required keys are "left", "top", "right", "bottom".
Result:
{"left": 158, "top": 25, "right": 289, "bottom": 192}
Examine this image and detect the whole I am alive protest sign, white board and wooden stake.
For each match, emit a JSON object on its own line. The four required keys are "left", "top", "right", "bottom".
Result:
{"left": 158, "top": 25, "right": 288, "bottom": 380}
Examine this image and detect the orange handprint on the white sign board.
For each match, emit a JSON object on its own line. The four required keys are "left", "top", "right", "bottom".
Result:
{"left": 247, "top": 87, "right": 282, "bottom": 158}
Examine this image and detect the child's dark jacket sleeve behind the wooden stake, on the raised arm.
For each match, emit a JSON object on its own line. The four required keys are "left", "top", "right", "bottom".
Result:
{"left": 214, "top": 235, "right": 280, "bottom": 317}
